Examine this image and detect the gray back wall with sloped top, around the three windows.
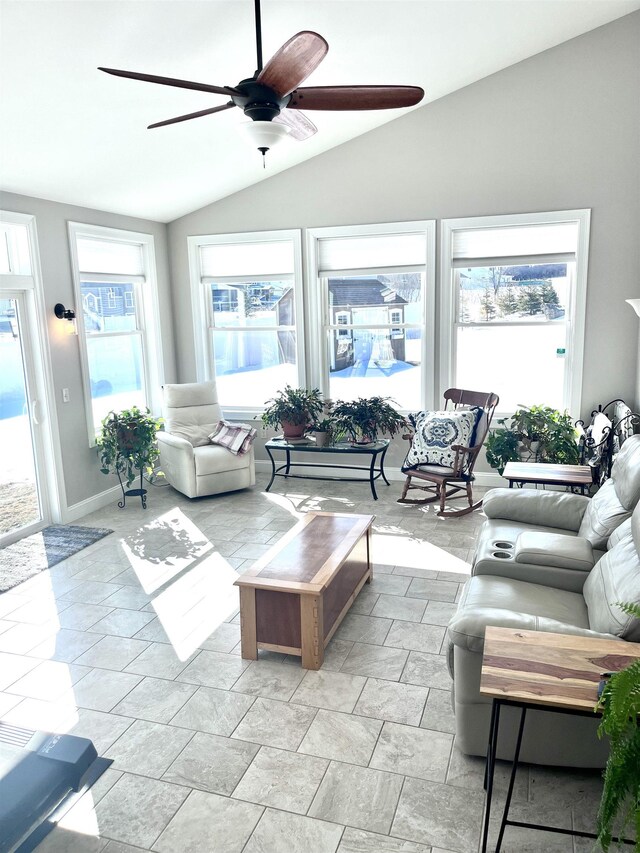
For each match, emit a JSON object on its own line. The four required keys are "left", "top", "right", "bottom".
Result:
{"left": 169, "top": 12, "right": 640, "bottom": 417}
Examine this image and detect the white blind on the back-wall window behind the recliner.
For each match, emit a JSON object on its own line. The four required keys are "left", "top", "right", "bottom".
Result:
{"left": 200, "top": 240, "right": 293, "bottom": 278}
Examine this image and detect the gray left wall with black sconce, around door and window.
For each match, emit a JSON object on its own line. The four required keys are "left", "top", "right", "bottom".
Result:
{"left": 0, "top": 192, "right": 176, "bottom": 506}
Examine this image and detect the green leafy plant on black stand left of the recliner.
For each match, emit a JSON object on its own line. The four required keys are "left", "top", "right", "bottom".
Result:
{"left": 97, "top": 406, "right": 162, "bottom": 486}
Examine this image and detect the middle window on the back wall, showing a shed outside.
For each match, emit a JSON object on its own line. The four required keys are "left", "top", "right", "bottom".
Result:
{"left": 309, "top": 222, "right": 435, "bottom": 410}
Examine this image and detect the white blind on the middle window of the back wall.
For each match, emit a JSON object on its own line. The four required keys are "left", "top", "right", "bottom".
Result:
{"left": 318, "top": 233, "right": 427, "bottom": 275}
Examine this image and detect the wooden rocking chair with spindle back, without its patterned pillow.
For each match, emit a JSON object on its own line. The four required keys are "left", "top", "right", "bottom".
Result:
{"left": 398, "top": 388, "right": 499, "bottom": 517}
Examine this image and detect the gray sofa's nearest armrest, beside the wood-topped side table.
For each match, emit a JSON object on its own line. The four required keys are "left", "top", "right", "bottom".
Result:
{"left": 447, "top": 607, "right": 620, "bottom": 654}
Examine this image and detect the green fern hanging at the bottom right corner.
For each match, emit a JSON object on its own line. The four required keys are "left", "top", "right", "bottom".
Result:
{"left": 597, "top": 604, "right": 640, "bottom": 853}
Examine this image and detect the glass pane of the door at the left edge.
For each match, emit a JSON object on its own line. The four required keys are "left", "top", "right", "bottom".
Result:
{"left": 0, "top": 290, "right": 48, "bottom": 545}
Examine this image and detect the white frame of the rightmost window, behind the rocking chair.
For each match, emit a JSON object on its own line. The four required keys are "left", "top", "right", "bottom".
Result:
{"left": 440, "top": 209, "right": 591, "bottom": 417}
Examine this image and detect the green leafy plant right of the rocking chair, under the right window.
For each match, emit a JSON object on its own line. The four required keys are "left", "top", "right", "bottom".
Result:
{"left": 487, "top": 406, "right": 580, "bottom": 474}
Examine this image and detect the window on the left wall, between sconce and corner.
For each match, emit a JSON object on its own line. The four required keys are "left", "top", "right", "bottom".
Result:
{"left": 69, "top": 222, "right": 162, "bottom": 443}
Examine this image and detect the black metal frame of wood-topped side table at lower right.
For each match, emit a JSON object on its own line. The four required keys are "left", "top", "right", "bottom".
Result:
{"left": 481, "top": 698, "right": 635, "bottom": 853}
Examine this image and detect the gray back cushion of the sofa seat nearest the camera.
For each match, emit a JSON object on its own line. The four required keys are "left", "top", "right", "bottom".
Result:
{"left": 583, "top": 504, "right": 640, "bottom": 643}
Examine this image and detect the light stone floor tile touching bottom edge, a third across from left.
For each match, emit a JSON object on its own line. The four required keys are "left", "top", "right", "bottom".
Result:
{"left": 153, "top": 786, "right": 263, "bottom": 853}
